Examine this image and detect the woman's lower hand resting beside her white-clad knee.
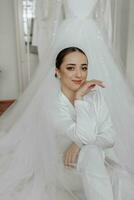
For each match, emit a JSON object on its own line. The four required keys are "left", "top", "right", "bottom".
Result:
{"left": 64, "top": 143, "right": 80, "bottom": 168}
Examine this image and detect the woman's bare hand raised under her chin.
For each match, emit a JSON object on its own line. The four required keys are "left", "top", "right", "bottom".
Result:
{"left": 75, "top": 80, "right": 105, "bottom": 99}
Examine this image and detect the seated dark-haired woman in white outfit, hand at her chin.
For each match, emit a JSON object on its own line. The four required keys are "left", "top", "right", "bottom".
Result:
{"left": 54, "top": 47, "right": 134, "bottom": 200}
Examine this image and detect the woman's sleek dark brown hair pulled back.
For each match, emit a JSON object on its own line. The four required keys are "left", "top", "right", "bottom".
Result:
{"left": 55, "top": 47, "right": 87, "bottom": 77}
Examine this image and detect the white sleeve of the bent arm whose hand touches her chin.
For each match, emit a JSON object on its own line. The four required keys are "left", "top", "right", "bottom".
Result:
{"left": 58, "top": 100, "right": 96, "bottom": 146}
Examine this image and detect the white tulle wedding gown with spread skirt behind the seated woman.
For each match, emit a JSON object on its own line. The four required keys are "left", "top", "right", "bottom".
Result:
{"left": 0, "top": 0, "right": 134, "bottom": 200}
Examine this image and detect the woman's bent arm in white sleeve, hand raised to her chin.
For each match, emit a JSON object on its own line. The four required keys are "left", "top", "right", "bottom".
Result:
{"left": 57, "top": 80, "right": 105, "bottom": 146}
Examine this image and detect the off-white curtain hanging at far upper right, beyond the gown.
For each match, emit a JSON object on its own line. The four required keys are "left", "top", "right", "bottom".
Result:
{"left": 112, "top": 0, "right": 130, "bottom": 71}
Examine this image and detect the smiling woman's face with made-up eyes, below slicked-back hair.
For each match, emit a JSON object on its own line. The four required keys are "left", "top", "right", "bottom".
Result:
{"left": 56, "top": 52, "right": 88, "bottom": 93}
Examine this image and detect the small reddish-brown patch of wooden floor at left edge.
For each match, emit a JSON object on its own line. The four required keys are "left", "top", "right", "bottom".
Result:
{"left": 0, "top": 99, "right": 15, "bottom": 116}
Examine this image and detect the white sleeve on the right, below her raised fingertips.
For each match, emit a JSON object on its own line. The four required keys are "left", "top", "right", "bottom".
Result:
{"left": 95, "top": 90, "right": 116, "bottom": 149}
